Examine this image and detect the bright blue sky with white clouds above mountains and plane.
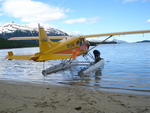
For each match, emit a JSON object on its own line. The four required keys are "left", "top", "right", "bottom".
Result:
{"left": 0, "top": 0, "right": 150, "bottom": 42}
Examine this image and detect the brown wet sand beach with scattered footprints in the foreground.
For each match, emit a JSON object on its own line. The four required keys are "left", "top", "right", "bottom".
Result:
{"left": 0, "top": 81, "right": 150, "bottom": 113}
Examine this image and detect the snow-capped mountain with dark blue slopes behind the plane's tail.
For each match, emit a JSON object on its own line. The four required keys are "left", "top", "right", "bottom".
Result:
{"left": 0, "top": 22, "right": 68, "bottom": 39}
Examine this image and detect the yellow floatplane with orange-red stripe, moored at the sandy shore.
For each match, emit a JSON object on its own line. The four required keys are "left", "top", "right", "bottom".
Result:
{"left": 6, "top": 25, "right": 150, "bottom": 74}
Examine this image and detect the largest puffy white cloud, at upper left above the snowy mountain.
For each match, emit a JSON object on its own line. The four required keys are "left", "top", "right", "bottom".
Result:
{"left": 0, "top": 0, "right": 69, "bottom": 23}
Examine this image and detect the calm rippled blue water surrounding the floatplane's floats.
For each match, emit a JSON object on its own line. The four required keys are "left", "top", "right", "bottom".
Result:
{"left": 0, "top": 43, "right": 150, "bottom": 94}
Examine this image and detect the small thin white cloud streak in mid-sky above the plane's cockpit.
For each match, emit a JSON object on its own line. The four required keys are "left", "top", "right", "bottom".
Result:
{"left": 64, "top": 17, "right": 101, "bottom": 24}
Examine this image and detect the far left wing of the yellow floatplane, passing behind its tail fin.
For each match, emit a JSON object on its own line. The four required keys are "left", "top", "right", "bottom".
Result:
{"left": 8, "top": 36, "right": 68, "bottom": 40}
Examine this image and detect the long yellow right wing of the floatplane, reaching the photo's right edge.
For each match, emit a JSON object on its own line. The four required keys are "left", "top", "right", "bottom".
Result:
{"left": 80, "top": 30, "right": 150, "bottom": 38}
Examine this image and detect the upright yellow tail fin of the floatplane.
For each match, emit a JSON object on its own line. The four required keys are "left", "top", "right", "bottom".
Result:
{"left": 39, "top": 25, "right": 55, "bottom": 52}
